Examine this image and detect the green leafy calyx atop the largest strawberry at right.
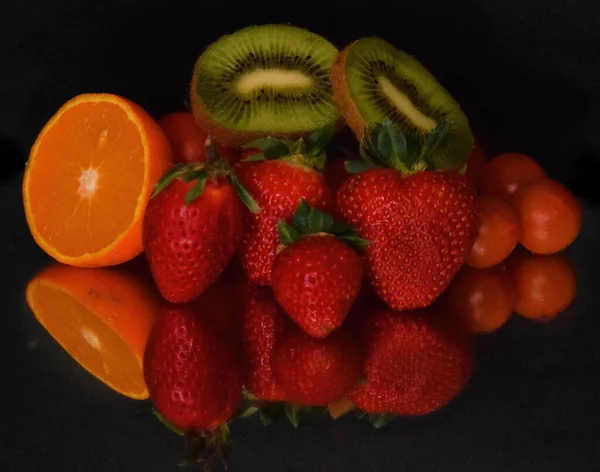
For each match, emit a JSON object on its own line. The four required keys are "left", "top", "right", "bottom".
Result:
{"left": 345, "top": 119, "right": 450, "bottom": 174}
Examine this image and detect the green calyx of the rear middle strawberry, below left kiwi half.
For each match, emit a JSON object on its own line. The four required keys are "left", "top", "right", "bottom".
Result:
{"left": 242, "top": 125, "right": 335, "bottom": 171}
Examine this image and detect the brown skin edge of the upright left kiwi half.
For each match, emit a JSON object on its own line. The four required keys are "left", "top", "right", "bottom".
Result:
{"left": 190, "top": 25, "right": 346, "bottom": 147}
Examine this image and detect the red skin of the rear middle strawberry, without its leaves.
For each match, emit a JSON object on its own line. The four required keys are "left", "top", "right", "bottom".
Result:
{"left": 237, "top": 159, "right": 333, "bottom": 285}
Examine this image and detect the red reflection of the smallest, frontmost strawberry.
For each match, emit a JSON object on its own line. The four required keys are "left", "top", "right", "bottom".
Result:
{"left": 271, "top": 326, "right": 362, "bottom": 406}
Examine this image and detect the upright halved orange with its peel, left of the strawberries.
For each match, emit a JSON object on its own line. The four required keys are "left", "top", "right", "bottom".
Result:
{"left": 23, "top": 94, "right": 171, "bottom": 267}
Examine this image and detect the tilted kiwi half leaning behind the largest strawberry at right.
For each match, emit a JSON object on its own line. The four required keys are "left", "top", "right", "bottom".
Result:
{"left": 331, "top": 38, "right": 473, "bottom": 170}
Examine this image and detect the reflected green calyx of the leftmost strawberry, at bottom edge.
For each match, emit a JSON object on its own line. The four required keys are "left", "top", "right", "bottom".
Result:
{"left": 154, "top": 410, "right": 231, "bottom": 466}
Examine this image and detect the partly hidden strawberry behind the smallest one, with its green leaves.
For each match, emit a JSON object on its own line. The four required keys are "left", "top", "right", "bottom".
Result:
{"left": 236, "top": 128, "right": 333, "bottom": 285}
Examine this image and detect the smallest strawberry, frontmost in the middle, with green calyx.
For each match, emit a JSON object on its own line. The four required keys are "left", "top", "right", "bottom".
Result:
{"left": 272, "top": 200, "right": 366, "bottom": 338}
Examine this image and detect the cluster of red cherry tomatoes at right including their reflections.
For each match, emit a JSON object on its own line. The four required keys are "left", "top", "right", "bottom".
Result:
{"left": 441, "top": 146, "right": 582, "bottom": 333}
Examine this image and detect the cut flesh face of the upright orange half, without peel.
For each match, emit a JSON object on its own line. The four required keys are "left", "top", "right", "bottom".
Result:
{"left": 28, "top": 102, "right": 145, "bottom": 257}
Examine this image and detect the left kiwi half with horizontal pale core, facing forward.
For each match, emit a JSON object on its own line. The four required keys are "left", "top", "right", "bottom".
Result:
{"left": 190, "top": 25, "right": 342, "bottom": 146}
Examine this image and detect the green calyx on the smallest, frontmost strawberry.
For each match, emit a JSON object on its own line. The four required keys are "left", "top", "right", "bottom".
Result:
{"left": 277, "top": 199, "right": 369, "bottom": 249}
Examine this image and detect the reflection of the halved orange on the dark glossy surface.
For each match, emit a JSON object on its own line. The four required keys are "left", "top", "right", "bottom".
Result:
{"left": 26, "top": 264, "right": 158, "bottom": 400}
